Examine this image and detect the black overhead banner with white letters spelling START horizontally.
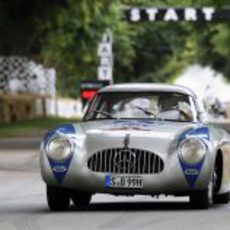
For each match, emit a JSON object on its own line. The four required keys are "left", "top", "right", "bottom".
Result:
{"left": 125, "top": 7, "right": 230, "bottom": 22}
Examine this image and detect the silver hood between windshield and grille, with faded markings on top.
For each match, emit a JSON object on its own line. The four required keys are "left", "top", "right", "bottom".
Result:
{"left": 81, "top": 120, "right": 197, "bottom": 155}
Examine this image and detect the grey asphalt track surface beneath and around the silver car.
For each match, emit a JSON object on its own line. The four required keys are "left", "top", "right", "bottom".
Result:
{"left": 0, "top": 129, "right": 230, "bottom": 230}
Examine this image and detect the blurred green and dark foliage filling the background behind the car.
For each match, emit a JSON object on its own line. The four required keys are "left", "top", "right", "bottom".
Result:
{"left": 0, "top": 0, "right": 230, "bottom": 97}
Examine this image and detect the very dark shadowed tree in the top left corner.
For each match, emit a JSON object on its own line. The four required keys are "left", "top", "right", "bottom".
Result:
{"left": 0, "top": 0, "right": 65, "bottom": 57}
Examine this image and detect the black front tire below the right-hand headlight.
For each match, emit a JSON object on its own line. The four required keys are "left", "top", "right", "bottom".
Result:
{"left": 190, "top": 189, "right": 211, "bottom": 209}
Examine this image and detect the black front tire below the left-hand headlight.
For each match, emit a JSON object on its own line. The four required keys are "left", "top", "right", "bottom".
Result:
{"left": 46, "top": 185, "right": 70, "bottom": 211}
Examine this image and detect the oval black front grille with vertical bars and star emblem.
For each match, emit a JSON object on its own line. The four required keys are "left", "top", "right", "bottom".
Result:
{"left": 88, "top": 148, "right": 164, "bottom": 174}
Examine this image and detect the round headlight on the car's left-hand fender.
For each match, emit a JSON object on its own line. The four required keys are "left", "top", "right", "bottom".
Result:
{"left": 46, "top": 137, "right": 72, "bottom": 161}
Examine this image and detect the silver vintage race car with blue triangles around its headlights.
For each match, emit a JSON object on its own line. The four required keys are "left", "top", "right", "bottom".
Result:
{"left": 40, "top": 84, "right": 230, "bottom": 210}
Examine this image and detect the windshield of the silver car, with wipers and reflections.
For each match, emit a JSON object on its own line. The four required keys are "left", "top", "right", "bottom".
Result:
{"left": 84, "top": 92, "right": 197, "bottom": 122}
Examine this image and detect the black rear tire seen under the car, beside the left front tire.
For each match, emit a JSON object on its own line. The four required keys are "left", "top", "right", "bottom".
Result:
{"left": 71, "top": 191, "right": 92, "bottom": 208}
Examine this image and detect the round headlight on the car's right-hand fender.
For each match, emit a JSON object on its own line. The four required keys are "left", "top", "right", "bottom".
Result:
{"left": 180, "top": 139, "right": 206, "bottom": 164}
